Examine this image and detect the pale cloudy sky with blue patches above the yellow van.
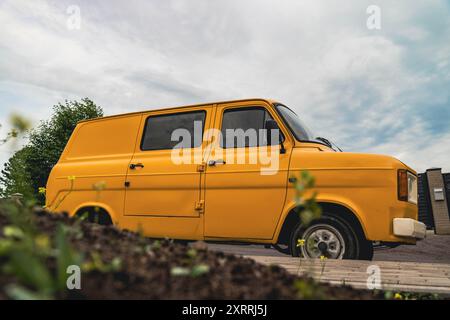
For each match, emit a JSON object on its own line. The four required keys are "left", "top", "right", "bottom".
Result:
{"left": 0, "top": 0, "right": 450, "bottom": 171}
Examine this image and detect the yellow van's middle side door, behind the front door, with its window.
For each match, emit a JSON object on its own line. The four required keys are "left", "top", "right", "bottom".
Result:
{"left": 124, "top": 106, "right": 212, "bottom": 220}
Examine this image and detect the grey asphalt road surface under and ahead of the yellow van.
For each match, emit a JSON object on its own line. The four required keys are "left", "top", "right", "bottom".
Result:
{"left": 208, "top": 235, "right": 450, "bottom": 264}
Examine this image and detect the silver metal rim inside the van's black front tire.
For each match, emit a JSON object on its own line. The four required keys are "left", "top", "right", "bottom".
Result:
{"left": 300, "top": 224, "right": 345, "bottom": 259}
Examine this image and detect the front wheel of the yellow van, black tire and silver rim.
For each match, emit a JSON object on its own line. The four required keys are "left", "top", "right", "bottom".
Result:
{"left": 290, "top": 214, "right": 360, "bottom": 259}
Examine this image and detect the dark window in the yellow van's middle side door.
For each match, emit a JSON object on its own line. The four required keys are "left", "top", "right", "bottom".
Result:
{"left": 141, "top": 110, "right": 206, "bottom": 151}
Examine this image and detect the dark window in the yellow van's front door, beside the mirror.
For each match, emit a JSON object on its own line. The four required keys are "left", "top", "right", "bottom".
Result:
{"left": 220, "top": 107, "right": 273, "bottom": 148}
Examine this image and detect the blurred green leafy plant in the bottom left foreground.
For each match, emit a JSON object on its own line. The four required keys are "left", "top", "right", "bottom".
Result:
{"left": 0, "top": 200, "right": 83, "bottom": 300}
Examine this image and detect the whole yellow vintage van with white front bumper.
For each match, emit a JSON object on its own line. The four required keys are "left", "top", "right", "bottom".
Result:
{"left": 46, "top": 99, "right": 426, "bottom": 259}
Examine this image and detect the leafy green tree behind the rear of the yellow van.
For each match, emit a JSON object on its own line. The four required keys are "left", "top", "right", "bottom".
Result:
{"left": 0, "top": 98, "right": 103, "bottom": 203}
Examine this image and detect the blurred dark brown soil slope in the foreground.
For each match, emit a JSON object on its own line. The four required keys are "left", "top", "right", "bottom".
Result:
{"left": 0, "top": 212, "right": 384, "bottom": 299}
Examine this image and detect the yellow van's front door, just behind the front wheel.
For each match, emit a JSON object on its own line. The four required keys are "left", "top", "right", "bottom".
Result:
{"left": 205, "top": 102, "right": 292, "bottom": 239}
